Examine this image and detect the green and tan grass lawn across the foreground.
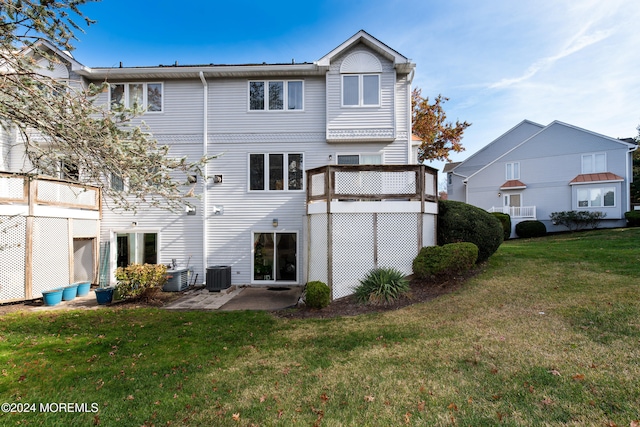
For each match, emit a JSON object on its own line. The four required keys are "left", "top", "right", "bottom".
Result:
{"left": 0, "top": 229, "right": 640, "bottom": 426}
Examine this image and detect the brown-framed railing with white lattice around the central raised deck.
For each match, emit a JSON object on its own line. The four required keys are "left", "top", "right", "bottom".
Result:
{"left": 307, "top": 165, "right": 438, "bottom": 203}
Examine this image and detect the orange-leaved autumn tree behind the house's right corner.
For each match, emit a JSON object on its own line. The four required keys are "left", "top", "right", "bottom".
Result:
{"left": 411, "top": 89, "right": 471, "bottom": 163}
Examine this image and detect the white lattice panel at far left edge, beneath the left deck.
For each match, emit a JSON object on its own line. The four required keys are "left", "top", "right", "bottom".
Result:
{"left": 0, "top": 216, "right": 26, "bottom": 301}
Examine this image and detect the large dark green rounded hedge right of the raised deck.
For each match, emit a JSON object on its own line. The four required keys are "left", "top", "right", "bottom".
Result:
{"left": 437, "top": 200, "right": 504, "bottom": 262}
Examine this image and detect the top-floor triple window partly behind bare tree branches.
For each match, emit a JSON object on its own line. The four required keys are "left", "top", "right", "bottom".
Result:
{"left": 109, "top": 83, "right": 163, "bottom": 113}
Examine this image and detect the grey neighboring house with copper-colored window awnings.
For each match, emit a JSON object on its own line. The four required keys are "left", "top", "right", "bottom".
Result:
{"left": 444, "top": 120, "right": 637, "bottom": 231}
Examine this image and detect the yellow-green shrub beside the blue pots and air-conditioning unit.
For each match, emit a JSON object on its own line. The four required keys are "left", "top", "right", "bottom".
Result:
{"left": 116, "top": 264, "right": 167, "bottom": 299}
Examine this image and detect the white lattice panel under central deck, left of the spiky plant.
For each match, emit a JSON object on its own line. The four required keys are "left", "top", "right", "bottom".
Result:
{"left": 331, "top": 213, "right": 374, "bottom": 299}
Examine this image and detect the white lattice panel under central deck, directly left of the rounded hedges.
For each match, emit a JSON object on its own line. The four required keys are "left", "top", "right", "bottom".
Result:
{"left": 377, "top": 213, "right": 420, "bottom": 275}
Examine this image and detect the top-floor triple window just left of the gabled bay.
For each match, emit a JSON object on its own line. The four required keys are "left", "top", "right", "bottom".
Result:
{"left": 249, "top": 80, "right": 303, "bottom": 111}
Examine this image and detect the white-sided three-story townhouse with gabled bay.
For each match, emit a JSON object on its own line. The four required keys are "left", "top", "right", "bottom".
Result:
{"left": 0, "top": 31, "right": 437, "bottom": 300}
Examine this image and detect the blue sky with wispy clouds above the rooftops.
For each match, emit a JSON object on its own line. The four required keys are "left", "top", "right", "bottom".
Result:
{"left": 73, "top": 0, "right": 640, "bottom": 177}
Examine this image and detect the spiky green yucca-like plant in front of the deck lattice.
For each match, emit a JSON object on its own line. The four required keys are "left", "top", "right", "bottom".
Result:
{"left": 354, "top": 268, "right": 409, "bottom": 305}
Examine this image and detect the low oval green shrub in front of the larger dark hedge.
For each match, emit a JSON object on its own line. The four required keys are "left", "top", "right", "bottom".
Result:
{"left": 413, "top": 242, "right": 478, "bottom": 279}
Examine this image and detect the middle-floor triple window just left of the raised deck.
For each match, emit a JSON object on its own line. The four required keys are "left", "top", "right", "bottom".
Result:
{"left": 249, "top": 153, "right": 303, "bottom": 191}
